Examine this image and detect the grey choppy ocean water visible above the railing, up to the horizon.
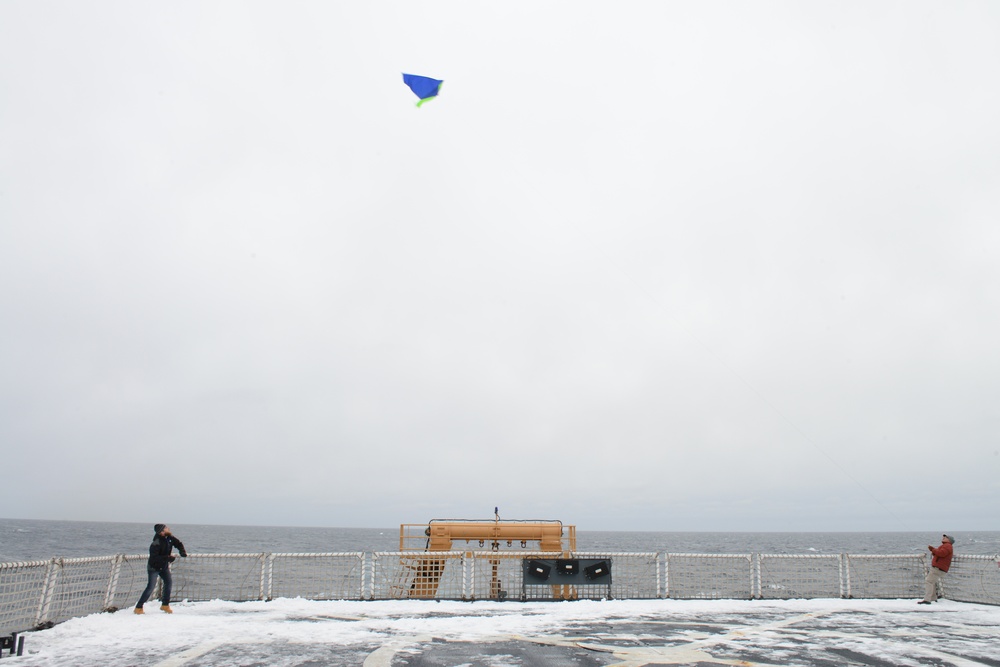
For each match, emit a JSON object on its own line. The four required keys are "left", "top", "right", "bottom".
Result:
{"left": 0, "top": 519, "right": 1000, "bottom": 562}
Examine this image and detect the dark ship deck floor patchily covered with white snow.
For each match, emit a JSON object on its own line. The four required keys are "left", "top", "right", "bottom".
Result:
{"left": 7, "top": 599, "right": 1000, "bottom": 667}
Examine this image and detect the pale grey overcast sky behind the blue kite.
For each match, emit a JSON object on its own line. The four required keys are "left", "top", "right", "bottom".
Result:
{"left": 0, "top": 0, "right": 1000, "bottom": 531}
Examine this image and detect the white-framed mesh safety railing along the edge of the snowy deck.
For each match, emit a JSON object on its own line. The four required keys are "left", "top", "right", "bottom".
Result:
{"left": 0, "top": 551, "right": 1000, "bottom": 634}
